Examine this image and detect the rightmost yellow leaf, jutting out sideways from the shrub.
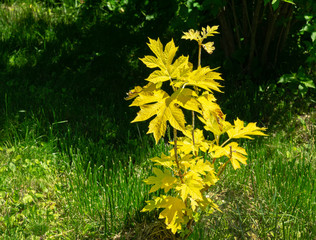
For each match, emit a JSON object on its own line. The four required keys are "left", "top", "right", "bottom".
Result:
{"left": 227, "top": 118, "right": 267, "bottom": 139}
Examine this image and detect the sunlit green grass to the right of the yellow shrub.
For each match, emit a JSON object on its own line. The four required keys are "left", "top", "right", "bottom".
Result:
{"left": 192, "top": 112, "right": 316, "bottom": 239}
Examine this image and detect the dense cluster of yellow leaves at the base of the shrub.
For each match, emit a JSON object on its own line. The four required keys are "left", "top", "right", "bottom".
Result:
{"left": 142, "top": 154, "right": 218, "bottom": 233}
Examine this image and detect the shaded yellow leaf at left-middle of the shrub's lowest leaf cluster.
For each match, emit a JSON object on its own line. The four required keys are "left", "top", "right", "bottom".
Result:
{"left": 144, "top": 168, "right": 177, "bottom": 193}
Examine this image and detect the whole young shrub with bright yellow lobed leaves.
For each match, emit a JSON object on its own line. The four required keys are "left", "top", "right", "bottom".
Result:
{"left": 126, "top": 26, "right": 266, "bottom": 239}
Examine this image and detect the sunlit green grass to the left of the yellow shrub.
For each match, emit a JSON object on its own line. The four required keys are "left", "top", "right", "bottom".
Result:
{"left": 0, "top": 112, "right": 165, "bottom": 239}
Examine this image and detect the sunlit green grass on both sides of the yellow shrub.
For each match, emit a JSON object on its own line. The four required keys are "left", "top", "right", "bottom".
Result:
{"left": 0, "top": 107, "right": 316, "bottom": 239}
